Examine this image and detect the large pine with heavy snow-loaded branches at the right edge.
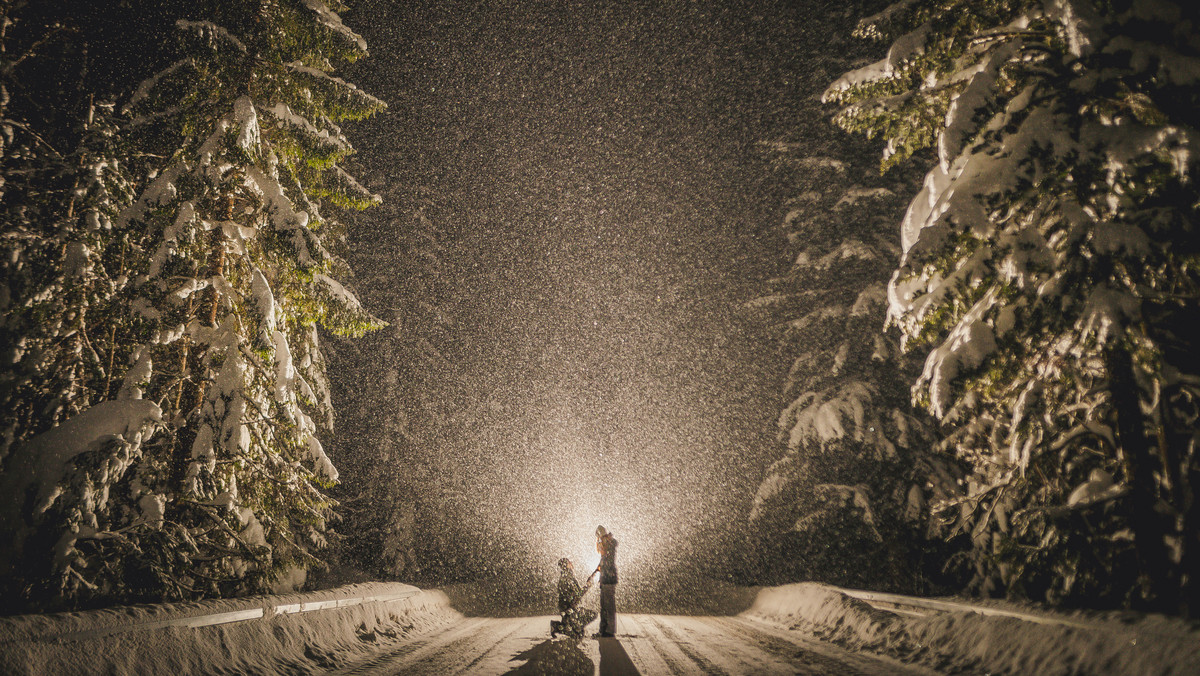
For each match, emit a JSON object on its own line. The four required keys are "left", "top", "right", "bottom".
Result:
{"left": 826, "top": 0, "right": 1200, "bottom": 609}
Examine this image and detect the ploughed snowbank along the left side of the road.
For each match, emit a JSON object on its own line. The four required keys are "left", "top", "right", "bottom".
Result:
{"left": 0, "top": 582, "right": 462, "bottom": 675}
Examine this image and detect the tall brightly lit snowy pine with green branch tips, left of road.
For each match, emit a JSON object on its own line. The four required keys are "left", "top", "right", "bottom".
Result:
{"left": 114, "top": 0, "right": 383, "bottom": 602}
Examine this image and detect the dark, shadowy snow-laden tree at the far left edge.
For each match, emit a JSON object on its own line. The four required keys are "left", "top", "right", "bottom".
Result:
{"left": 0, "top": 4, "right": 170, "bottom": 610}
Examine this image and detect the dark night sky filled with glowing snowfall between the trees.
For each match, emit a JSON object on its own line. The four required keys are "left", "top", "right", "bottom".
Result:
{"left": 344, "top": 0, "right": 864, "bottom": 576}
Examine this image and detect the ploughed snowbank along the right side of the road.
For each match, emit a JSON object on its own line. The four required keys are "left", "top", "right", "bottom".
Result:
{"left": 742, "top": 582, "right": 1200, "bottom": 676}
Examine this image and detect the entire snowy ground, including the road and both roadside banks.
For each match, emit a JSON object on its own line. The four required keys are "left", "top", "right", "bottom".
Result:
{"left": 0, "top": 582, "right": 1200, "bottom": 676}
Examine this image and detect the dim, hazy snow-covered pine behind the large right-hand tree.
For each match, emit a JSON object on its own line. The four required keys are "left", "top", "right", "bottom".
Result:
{"left": 748, "top": 1, "right": 954, "bottom": 590}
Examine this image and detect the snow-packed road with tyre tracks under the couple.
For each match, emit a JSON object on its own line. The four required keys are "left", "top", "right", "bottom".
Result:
{"left": 331, "top": 615, "right": 931, "bottom": 676}
